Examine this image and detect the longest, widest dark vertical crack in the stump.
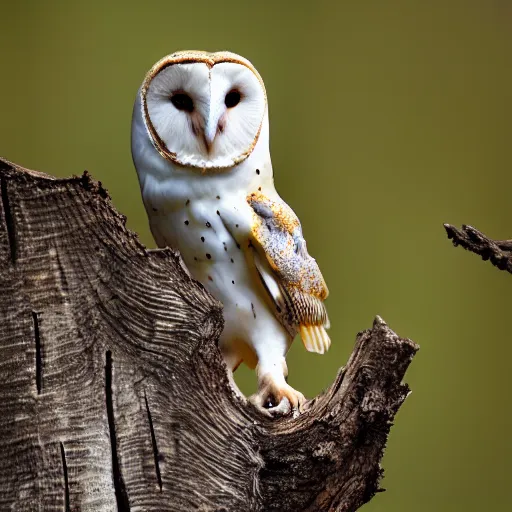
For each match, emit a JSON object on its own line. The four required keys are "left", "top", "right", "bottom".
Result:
{"left": 105, "top": 350, "right": 130, "bottom": 512}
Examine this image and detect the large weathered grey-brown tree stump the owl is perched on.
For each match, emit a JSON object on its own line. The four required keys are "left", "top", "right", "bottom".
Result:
{"left": 0, "top": 160, "right": 417, "bottom": 512}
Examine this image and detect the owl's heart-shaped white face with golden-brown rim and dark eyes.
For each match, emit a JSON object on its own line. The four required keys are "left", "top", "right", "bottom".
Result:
{"left": 138, "top": 51, "right": 267, "bottom": 169}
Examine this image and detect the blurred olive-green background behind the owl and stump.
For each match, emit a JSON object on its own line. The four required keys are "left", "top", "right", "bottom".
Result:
{"left": 0, "top": 0, "right": 512, "bottom": 512}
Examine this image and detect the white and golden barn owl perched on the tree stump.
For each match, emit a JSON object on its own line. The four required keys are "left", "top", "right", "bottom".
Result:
{"left": 132, "top": 51, "right": 330, "bottom": 413}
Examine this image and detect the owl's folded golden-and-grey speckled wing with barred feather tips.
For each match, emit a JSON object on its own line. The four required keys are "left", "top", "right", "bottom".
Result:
{"left": 247, "top": 193, "right": 331, "bottom": 354}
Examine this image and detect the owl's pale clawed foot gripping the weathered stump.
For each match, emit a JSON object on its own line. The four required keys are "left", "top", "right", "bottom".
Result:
{"left": 249, "top": 374, "right": 306, "bottom": 417}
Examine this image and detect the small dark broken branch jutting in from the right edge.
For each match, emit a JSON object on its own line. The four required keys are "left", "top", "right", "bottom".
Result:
{"left": 444, "top": 224, "right": 512, "bottom": 274}
